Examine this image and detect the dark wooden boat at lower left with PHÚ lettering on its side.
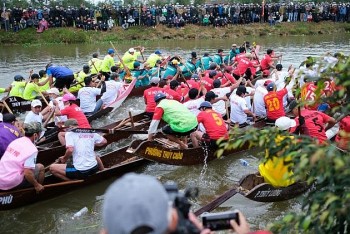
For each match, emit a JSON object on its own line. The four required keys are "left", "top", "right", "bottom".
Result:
{"left": 0, "top": 147, "right": 147, "bottom": 211}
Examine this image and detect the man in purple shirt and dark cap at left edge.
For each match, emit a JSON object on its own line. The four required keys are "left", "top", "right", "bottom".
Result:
{"left": 0, "top": 113, "right": 21, "bottom": 159}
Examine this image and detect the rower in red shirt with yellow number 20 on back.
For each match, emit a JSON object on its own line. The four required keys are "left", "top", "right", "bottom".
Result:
{"left": 264, "top": 82, "right": 288, "bottom": 123}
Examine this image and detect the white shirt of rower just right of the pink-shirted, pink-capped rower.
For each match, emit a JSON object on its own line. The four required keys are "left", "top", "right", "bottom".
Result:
{"left": 78, "top": 87, "right": 101, "bottom": 113}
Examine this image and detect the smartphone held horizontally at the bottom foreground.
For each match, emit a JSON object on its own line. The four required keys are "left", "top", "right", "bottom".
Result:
{"left": 202, "top": 210, "right": 239, "bottom": 231}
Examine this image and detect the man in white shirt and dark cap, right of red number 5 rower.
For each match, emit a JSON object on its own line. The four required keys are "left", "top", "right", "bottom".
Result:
{"left": 230, "top": 86, "right": 256, "bottom": 127}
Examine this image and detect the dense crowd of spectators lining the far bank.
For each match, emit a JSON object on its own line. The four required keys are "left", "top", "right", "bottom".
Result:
{"left": 1, "top": 2, "right": 350, "bottom": 31}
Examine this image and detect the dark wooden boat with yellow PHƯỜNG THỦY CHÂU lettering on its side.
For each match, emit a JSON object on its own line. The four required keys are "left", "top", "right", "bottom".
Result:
{"left": 128, "top": 120, "right": 266, "bottom": 166}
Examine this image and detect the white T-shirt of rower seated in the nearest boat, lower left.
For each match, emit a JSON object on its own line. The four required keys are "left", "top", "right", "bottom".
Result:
{"left": 65, "top": 132, "right": 103, "bottom": 171}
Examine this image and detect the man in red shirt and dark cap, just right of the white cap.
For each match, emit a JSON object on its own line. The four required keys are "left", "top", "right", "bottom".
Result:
{"left": 289, "top": 100, "right": 336, "bottom": 143}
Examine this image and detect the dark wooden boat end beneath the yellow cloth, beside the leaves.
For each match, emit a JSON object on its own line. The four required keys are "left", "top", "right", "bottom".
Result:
{"left": 238, "top": 174, "right": 310, "bottom": 202}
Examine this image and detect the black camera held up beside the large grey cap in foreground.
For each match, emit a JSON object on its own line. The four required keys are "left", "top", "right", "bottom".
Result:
{"left": 163, "top": 181, "right": 200, "bottom": 234}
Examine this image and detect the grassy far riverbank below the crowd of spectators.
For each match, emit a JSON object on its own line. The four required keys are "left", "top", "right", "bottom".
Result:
{"left": 0, "top": 22, "right": 350, "bottom": 46}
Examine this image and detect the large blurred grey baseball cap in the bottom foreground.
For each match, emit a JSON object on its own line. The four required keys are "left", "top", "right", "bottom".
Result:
{"left": 102, "top": 173, "right": 170, "bottom": 234}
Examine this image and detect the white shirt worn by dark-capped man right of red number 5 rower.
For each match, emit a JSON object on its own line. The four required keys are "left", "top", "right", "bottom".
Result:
{"left": 230, "top": 93, "right": 249, "bottom": 124}
